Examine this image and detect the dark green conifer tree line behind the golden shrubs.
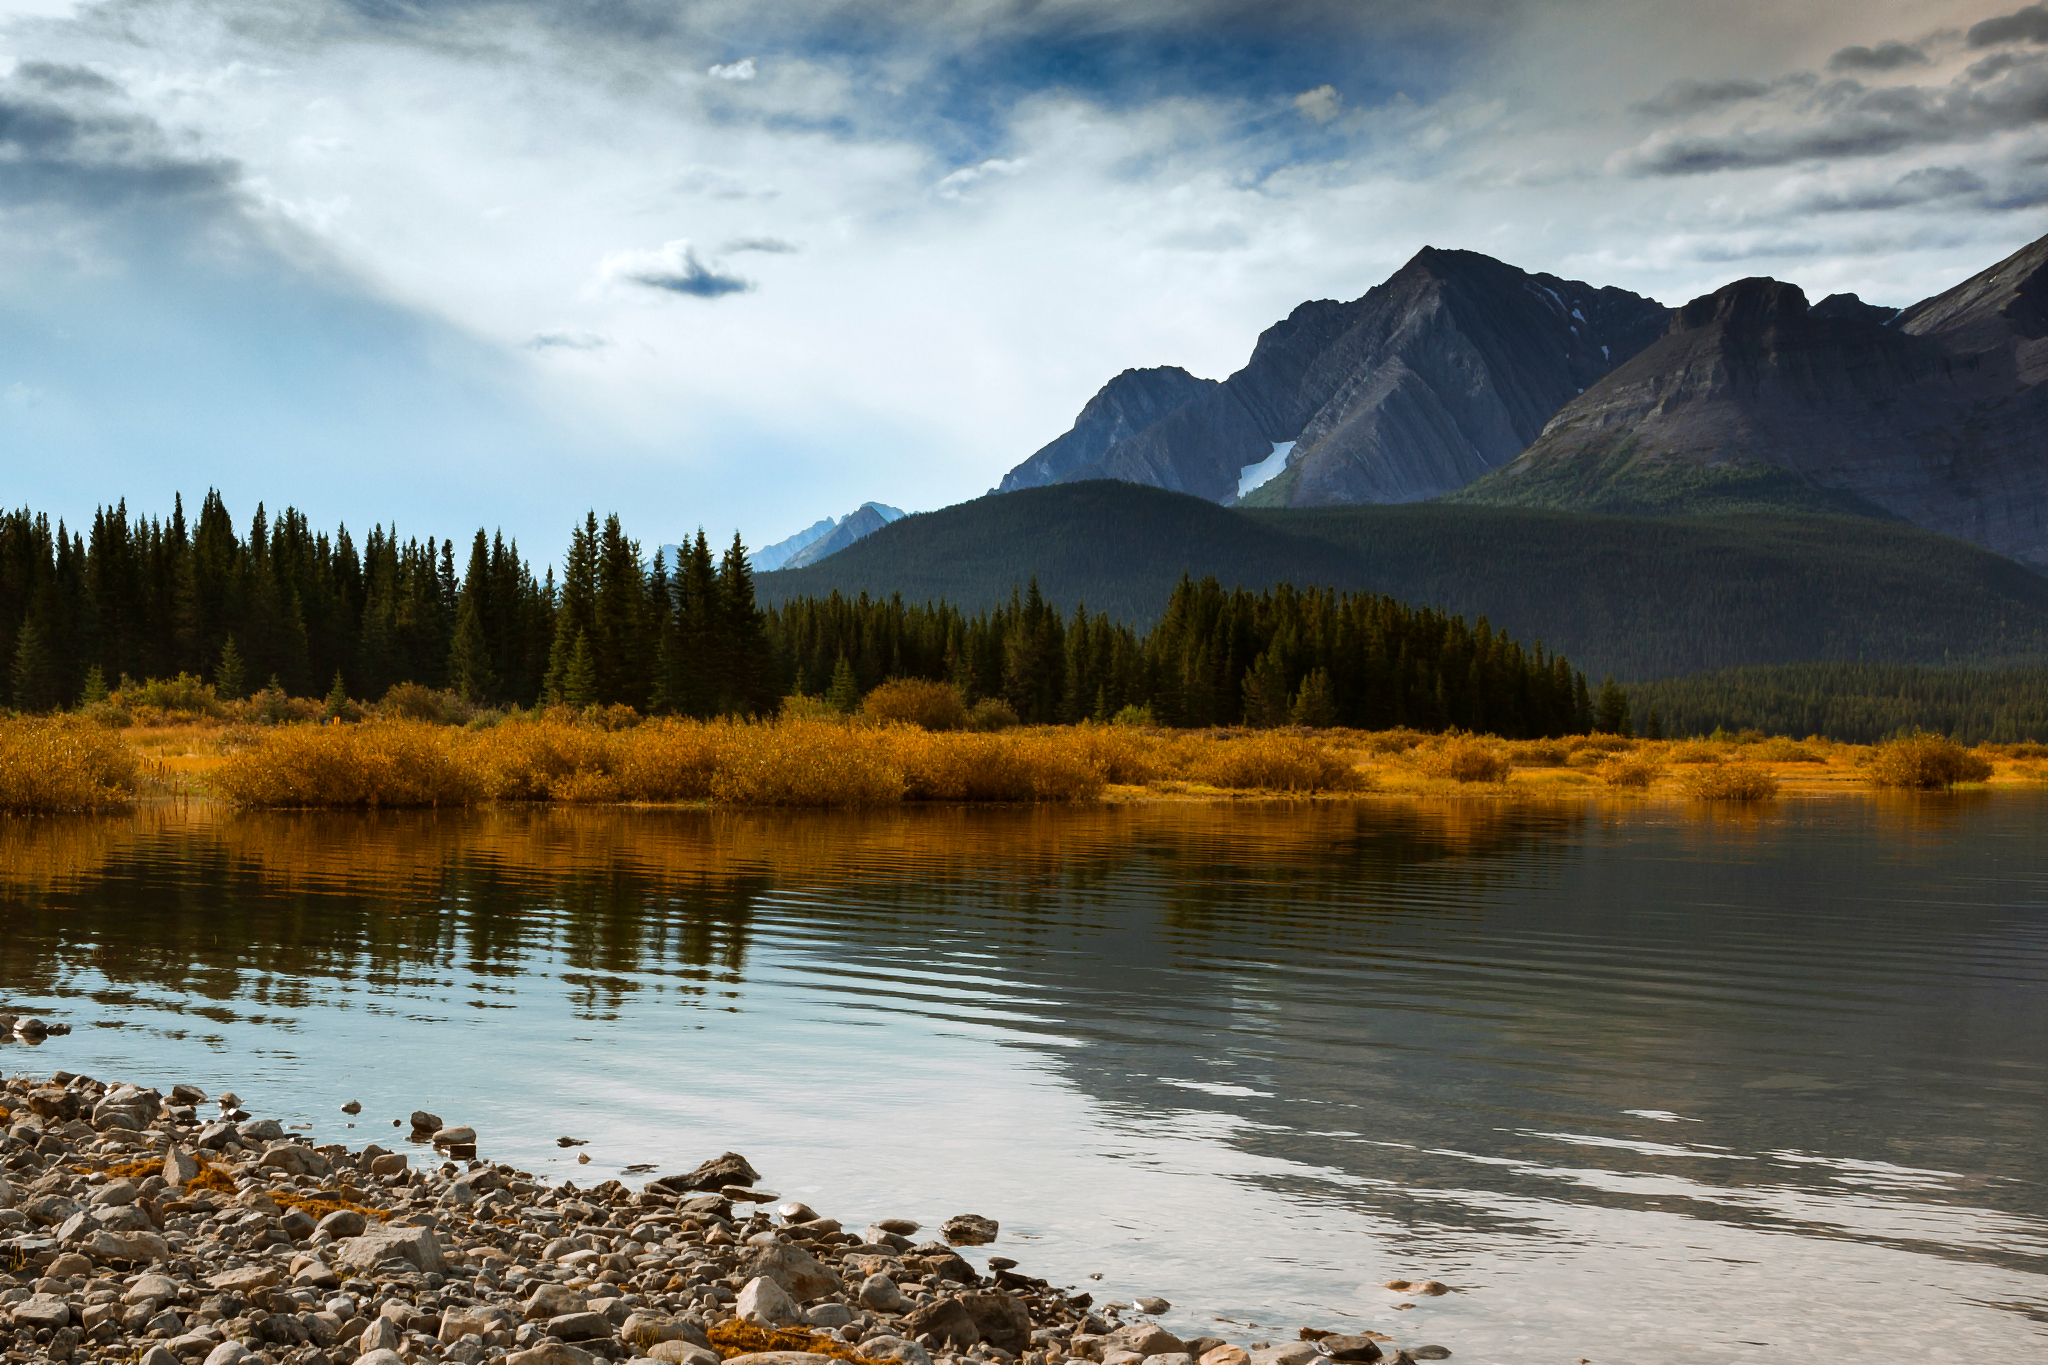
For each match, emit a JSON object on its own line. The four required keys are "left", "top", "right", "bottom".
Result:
{"left": 0, "top": 493, "right": 1589, "bottom": 737}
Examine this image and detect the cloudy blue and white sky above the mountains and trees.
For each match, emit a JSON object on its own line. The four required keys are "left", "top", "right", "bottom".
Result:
{"left": 0, "top": 0, "right": 2048, "bottom": 561}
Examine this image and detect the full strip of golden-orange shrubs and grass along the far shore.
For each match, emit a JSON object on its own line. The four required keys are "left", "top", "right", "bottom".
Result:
{"left": 0, "top": 699, "right": 2023, "bottom": 812}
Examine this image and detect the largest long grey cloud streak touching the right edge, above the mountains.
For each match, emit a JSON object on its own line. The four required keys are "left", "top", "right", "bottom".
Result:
{"left": 1622, "top": 55, "right": 2048, "bottom": 176}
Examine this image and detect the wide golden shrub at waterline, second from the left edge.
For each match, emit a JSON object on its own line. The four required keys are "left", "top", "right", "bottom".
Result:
{"left": 209, "top": 720, "right": 487, "bottom": 806}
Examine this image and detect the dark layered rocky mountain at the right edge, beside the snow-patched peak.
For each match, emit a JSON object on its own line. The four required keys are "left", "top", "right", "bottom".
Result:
{"left": 1454, "top": 237, "right": 2048, "bottom": 569}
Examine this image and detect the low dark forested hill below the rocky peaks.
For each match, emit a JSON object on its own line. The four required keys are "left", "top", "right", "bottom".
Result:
{"left": 756, "top": 481, "right": 2048, "bottom": 679}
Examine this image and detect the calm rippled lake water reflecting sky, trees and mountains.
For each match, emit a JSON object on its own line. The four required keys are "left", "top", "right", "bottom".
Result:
{"left": 0, "top": 796, "right": 2048, "bottom": 1363}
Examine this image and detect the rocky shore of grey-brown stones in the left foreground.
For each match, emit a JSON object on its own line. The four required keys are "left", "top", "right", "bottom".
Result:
{"left": 0, "top": 1072, "right": 1450, "bottom": 1365}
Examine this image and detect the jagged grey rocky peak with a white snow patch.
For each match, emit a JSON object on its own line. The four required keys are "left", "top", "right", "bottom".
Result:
{"left": 1004, "top": 248, "right": 1669, "bottom": 505}
